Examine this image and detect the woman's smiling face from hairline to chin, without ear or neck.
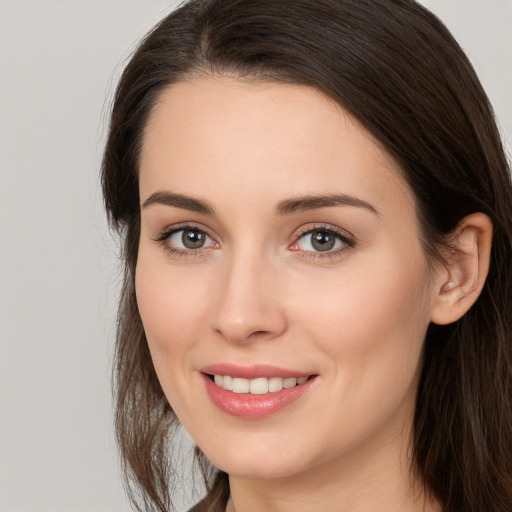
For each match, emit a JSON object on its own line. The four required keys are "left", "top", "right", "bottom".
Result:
{"left": 136, "top": 78, "right": 440, "bottom": 477}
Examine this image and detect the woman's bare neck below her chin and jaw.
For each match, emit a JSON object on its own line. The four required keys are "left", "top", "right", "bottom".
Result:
{"left": 226, "top": 424, "right": 441, "bottom": 512}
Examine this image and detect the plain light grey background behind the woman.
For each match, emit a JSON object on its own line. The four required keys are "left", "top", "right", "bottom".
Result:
{"left": 0, "top": 0, "right": 512, "bottom": 512}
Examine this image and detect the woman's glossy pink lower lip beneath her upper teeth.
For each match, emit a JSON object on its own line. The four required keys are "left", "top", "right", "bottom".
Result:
{"left": 201, "top": 373, "right": 316, "bottom": 418}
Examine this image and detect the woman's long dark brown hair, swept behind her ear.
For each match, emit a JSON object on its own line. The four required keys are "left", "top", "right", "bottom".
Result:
{"left": 102, "top": 0, "right": 512, "bottom": 512}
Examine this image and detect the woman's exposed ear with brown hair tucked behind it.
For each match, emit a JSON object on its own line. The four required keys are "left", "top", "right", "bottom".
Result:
{"left": 430, "top": 213, "right": 493, "bottom": 325}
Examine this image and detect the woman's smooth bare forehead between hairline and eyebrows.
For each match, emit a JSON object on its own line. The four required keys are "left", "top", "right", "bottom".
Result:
{"left": 140, "top": 77, "right": 414, "bottom": 214}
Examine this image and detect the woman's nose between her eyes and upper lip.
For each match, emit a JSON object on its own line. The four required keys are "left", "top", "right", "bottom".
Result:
{"left": 212, "top": 250, "right": 287, "bottom": 343}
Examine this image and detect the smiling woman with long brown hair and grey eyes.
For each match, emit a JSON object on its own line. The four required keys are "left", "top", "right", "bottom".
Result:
{"left": 103, "top": 0, "right": 512, "bottom": 512}
